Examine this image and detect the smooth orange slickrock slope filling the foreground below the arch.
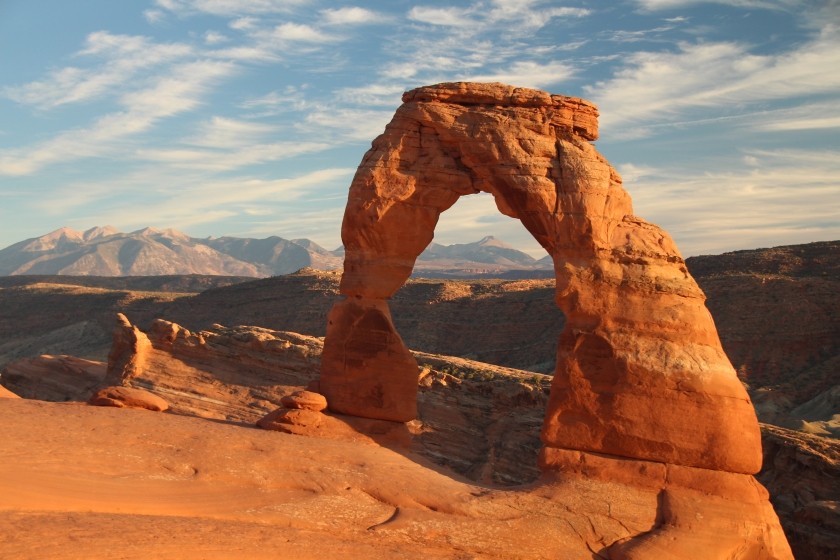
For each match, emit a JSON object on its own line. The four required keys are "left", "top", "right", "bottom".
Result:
{"left": 0, "top": 399, "right": 656, "bottom": 560}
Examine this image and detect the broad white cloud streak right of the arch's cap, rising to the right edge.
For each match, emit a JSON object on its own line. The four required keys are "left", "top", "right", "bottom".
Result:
{"left": 585, "top": 26, "right": 840, "bottom": 129}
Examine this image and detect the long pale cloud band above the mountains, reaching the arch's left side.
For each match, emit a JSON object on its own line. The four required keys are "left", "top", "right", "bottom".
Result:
{"left": 38, "top": 164, "right": 355, "bottom": 246}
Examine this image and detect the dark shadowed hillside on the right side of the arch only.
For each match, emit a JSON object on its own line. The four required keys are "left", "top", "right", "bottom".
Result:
{"left": 687, "top": 241, "right": 840, "bottom": 437}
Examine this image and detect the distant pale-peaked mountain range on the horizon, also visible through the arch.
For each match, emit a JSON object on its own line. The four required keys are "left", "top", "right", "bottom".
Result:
{"left": 0, "top": 226, "right": 552, "bottom": 278}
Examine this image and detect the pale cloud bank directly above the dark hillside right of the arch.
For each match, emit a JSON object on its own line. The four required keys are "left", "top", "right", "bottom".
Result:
{"left": 619, "top": 150, "right": 840, "bottom": 255}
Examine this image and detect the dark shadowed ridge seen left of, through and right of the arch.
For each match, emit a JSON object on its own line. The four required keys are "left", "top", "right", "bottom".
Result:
{"left": 0, "top": 242, "right": 840, "bottom": 416}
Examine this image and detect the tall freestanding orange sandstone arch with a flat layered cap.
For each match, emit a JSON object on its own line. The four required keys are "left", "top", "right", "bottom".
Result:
{"left": 320, "top": 83, "right": 761, "bottom": 473}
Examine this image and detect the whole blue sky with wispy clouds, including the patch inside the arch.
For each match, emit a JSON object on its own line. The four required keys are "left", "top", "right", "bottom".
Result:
{"left": 0, "top": 0, "right": 840, "bottom": 256}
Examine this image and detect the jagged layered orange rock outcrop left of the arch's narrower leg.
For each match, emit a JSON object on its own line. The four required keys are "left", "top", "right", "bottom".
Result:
{"left": 99, "top": 316, "right": 321, "bottom": 422}
